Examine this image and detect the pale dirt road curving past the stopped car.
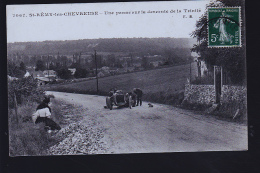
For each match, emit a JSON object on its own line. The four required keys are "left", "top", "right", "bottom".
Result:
{"left": 48, "top": 91, "right": 247, "bottom": 154}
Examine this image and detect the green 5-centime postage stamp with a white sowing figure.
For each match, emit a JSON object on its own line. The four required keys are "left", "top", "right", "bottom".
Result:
{"left": 208, "top": 7, "right": 241, "bottom": 47}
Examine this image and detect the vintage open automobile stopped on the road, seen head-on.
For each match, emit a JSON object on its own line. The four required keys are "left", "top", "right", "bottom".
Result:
{"left": 106, "top": 90, "right": 136, "bottom": 110}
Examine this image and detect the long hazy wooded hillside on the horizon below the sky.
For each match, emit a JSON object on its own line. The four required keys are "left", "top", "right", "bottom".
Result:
{"left": 7, "top": 38, "right": 195, "bottom": 55}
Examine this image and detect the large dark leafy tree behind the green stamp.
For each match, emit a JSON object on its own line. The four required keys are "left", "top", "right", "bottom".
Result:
{"left": 191, "top": 0, "right": 246, "bottom": 84}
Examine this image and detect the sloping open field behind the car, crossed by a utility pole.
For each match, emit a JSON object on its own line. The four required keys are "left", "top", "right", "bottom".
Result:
{"left": 47, "top": 63, "right": 197, "bottom": 104}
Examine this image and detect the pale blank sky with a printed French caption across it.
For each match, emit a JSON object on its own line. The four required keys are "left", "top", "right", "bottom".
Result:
{"left": 7, "top": 1, "right": 209, "bottom": 43}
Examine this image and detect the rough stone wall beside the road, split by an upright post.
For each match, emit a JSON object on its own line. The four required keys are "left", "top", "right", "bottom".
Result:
{"left": 184, "top": 84, "right": 247, "bottom": 105}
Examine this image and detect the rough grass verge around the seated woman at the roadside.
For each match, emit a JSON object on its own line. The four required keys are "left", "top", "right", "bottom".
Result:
{"left": 8, "top": 99, "right": 78, "bottom": 156}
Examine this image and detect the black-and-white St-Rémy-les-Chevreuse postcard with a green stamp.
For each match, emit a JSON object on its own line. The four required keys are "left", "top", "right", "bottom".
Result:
{"left": 6, "top": 0, "right": 248, "bottom": 156}
